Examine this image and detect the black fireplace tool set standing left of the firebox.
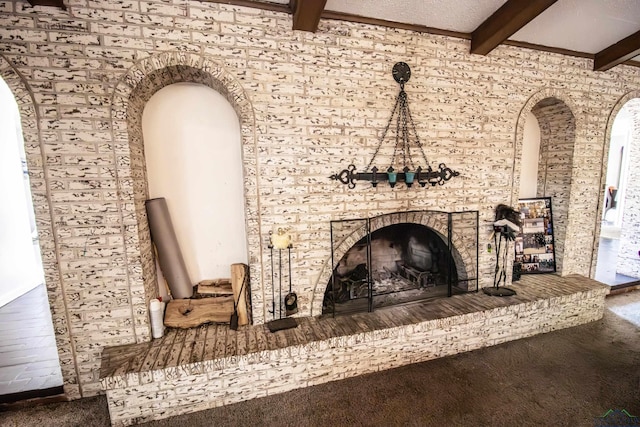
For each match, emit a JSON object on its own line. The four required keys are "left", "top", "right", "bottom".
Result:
{"left": 267, "top": 227, "right": 298, "bottom": 332}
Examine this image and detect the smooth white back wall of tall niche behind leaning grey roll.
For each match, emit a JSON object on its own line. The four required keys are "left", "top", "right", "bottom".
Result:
{"left": 142, "top": 83, "right": 248, "bottom": 290}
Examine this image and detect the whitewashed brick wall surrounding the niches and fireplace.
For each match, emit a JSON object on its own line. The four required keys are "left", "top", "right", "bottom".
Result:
{"left": 0, "top": 0, "right": 640, "bottom": 397}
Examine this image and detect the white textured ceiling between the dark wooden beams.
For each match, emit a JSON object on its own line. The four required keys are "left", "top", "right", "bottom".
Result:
{"left": 264, "top": 0, "right": 640, "bottom": 61}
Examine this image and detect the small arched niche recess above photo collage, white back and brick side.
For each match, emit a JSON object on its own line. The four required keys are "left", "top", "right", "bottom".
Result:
{"left": 519, "top": 97, "right": 576, "bottom": 273}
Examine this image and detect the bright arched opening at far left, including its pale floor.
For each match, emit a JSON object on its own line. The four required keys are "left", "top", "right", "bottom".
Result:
{"left": 0, "top": 79, "right": 62, "bottom": 402}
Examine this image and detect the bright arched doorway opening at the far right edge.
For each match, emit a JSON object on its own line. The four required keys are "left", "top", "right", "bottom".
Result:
{"left": 595, "top": 98, "right": 640, "bottom": 286}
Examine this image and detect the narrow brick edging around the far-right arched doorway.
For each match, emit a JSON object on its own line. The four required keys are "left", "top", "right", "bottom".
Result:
{"left": 589, "top": 90, "right": 640, "bottom": 277}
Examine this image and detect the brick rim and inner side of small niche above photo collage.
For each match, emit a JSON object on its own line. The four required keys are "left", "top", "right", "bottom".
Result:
{"left": 512, "top": 89, "right": 582, "bottom": 274}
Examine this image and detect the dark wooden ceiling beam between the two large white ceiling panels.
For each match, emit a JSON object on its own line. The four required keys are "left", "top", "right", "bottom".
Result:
{"left": 471, "top": 0, "right": 557, "bottom": 55}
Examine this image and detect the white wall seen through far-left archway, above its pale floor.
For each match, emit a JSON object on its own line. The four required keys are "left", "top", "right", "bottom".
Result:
{"left": 0, "top": 79, "right": 44, "bottom": 307}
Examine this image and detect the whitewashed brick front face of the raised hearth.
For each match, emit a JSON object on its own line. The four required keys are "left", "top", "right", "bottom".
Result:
{"left": 102, "top": 284, "right": 607, "bottom": 426}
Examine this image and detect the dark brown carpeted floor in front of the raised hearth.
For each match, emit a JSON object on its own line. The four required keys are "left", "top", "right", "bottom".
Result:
{"left": 0, "top": 291, "right": 640, "bottom": 427}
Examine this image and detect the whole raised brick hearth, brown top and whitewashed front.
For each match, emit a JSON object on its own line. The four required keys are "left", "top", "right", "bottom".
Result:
{"left": 101, "top": 275, "right": 607, "bottom": 426}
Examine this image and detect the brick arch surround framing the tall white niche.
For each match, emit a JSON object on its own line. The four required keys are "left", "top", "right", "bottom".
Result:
{"left": 111, "top": 52, "right": 262, "bottom": 330}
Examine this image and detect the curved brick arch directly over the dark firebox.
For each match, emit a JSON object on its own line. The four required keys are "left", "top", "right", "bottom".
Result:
{"left": 311, "top": 211, "right": 477, "bottom": 316}
